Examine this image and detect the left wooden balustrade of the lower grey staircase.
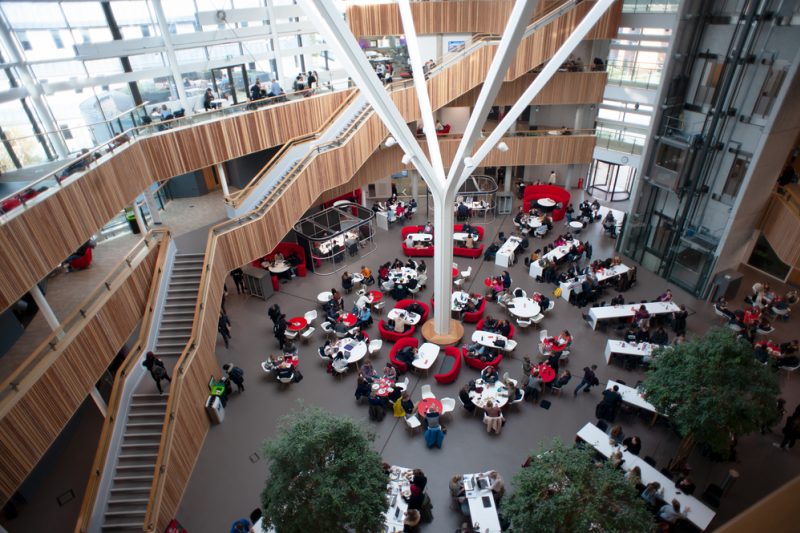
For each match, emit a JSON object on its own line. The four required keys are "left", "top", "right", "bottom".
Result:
{"left": 75, "top": 229, "right": 172, "bottom": 533}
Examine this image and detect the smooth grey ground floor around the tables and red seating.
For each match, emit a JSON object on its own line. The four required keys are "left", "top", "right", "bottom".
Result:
{"left": 176, "top": 191, "right": 800, "bottom": 533}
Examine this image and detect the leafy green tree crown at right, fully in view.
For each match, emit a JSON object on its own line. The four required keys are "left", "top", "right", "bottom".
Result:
{"left": 641, "top": 328, "right": 781, "bottom": 456}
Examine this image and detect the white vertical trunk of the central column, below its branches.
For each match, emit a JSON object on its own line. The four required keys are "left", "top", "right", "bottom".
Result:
{"left": 431, "top": 193, "right": 454, "bottom": 335}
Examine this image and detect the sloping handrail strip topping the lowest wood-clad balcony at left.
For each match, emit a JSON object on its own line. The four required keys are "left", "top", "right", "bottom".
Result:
{"left": 0, "top": 230, "right": 163, "bottom": 417}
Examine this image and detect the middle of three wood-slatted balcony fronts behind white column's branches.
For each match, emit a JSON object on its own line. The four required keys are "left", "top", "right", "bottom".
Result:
{"left": 446, "top": 72, "right": 608, "bottom": 107}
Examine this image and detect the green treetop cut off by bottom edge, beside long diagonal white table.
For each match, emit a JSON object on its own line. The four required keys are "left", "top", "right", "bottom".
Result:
{"left": 503, "top": 438, "right": 653, "bottom": 533}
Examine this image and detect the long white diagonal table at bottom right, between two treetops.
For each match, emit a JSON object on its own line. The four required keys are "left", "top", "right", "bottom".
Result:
{"left": 578, "top": 422, "right": 716, "bottom": 531}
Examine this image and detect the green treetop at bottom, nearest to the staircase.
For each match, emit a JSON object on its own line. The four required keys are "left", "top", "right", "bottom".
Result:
{"left": 257, "top": 402, "right": 388, "bottom": 533}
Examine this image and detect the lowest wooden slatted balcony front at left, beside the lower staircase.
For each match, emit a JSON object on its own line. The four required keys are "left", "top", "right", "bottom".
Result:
{"left": 0, "top": 245, "right": 159, "bottom": 503}
